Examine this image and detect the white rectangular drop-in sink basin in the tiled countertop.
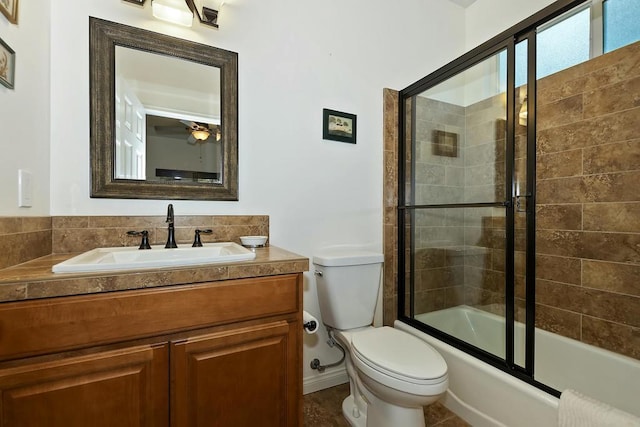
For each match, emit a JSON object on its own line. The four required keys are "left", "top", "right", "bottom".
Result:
{"left": 51, "top": 242, "right": 256, "bottom": 273}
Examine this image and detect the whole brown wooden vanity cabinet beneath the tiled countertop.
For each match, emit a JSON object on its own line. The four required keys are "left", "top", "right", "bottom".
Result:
{"left": 0, "top": 273, "right": 302, "bottom": 427}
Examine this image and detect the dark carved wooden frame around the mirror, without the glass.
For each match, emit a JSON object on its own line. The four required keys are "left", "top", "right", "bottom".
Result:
{"left": 89, "top": 17, "right": 238, "bottom": 200}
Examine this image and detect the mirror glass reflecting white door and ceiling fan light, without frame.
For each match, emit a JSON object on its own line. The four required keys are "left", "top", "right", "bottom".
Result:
{"left": 114, "top": 46, "right": 222, "bottom": 183}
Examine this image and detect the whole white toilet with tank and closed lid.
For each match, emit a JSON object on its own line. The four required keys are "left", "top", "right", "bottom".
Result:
{"left": 313, "top": 248, "right": 448, "bottom": 427}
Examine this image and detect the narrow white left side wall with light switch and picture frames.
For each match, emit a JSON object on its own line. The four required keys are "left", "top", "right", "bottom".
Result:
{"left": 0, "top": 1, "right": 51, "bottom": 216}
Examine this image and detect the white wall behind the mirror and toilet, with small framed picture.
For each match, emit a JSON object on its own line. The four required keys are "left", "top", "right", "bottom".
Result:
{"left": 48, "top": 0, "right": 464, "bottom": 390}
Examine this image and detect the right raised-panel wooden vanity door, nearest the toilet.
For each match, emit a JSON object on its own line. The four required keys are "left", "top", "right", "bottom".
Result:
{"left": 171, "top": 321, "right": 300, "bottom": 427}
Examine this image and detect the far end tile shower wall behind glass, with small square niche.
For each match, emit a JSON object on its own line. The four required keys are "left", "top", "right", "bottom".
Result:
{"left": 406, "top": 96, "right": 466, "bottom": 313}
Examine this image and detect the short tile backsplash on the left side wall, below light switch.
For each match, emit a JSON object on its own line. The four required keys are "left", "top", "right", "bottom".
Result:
{"left": 0, "top": 217, "right": 51, "bottom": 269}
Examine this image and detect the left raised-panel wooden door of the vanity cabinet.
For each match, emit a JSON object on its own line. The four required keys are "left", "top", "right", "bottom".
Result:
{"left": 0, "top": 343, "right": 169, "bottom": 427}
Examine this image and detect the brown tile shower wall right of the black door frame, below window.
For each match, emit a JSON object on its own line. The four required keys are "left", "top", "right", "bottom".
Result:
{"left": 536, "top": 42, "right": 640, "bottom": 359}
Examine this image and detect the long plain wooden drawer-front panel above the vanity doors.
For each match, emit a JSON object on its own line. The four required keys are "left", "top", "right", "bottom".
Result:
{"left": 0, "top": 273, "right": 302, "bottom": 360}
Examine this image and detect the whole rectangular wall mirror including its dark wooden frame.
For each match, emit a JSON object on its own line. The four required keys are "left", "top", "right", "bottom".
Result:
{"left": 89, "top": 17, "right": 238, "bottom": 200}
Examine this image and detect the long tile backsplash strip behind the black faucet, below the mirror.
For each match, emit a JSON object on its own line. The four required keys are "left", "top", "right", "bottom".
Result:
{"left": 52, "top": 215, "right": 269, "bottom": 253}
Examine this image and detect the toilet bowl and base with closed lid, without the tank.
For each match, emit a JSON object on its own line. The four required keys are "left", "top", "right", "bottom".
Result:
{"left": 334, "top": 326, "right": 448, "bottom": 427}
